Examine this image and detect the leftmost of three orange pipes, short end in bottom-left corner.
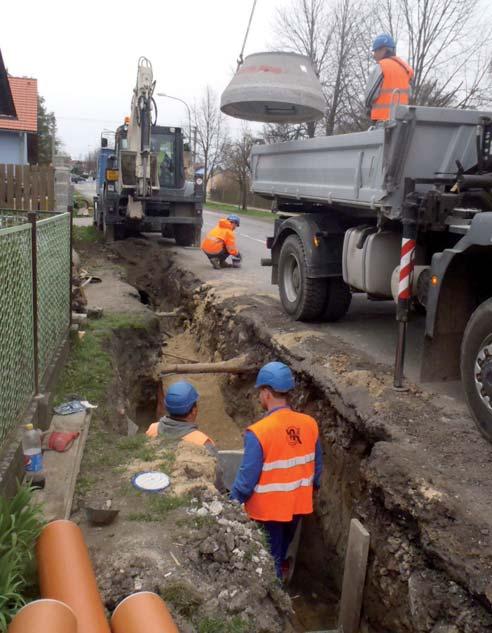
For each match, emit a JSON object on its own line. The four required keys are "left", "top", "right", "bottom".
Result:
{"left": 7, "top": 600, "right": 77, "bottom": 633}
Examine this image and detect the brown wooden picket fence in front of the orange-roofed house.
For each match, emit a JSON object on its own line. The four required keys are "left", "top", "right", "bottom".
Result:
{"left": 0, "top": 163, "right": 55, "bottom": 211}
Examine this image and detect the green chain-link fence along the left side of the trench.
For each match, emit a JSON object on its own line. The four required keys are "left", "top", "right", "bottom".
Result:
{"left": 0, "top": 211, "right": 71, "bottom": 448}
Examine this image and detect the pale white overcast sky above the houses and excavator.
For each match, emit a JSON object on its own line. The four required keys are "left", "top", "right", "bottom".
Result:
{"left": 0, "top": 0, "right": 289, "bottom": 158}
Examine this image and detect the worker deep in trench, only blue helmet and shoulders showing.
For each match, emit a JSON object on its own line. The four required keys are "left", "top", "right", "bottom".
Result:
{"left": 146, "top": 380, "right": 225, "bottom": 492}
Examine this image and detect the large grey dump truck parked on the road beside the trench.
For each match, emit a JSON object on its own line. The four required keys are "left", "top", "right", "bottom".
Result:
{"left": 251, "top": 106, "right": 492, "bottom": 441}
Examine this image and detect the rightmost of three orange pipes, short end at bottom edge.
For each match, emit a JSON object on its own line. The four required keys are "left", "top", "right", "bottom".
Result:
{"left": 111, "top": 591, "right": 179, "bottom": 633}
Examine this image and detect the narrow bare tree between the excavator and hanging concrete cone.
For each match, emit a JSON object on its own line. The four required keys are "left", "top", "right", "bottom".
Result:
{"left": 192, "top": 86, "right": 227, "bottom": 198}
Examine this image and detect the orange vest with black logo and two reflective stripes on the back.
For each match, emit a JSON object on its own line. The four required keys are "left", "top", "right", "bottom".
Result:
{"left": 244, "top": 408, "right": 319, "bottom": 521}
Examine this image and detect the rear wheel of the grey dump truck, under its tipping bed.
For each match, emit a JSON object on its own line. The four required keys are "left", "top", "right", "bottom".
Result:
{"left": 278, "top": 235, "right": 327, "bottom": 321}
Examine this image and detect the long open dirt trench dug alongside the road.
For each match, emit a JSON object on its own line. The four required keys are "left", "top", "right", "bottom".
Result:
{"left": 104, "top": 238, "right": 492, "bottom": 633}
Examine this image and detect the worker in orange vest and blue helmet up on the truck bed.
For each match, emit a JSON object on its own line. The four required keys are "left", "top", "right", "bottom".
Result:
{"left": 365, "top": 33, "right": 413, "bottom": 123}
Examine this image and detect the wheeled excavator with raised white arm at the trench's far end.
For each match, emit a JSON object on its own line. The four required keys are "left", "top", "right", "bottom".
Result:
{"left": 94, "top": 58, "right": 203, "bottom": 246}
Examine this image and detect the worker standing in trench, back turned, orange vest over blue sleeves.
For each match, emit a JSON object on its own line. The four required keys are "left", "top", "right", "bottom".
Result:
{"left": 231, "top": 362, "right": 323, "bottom": 579}
